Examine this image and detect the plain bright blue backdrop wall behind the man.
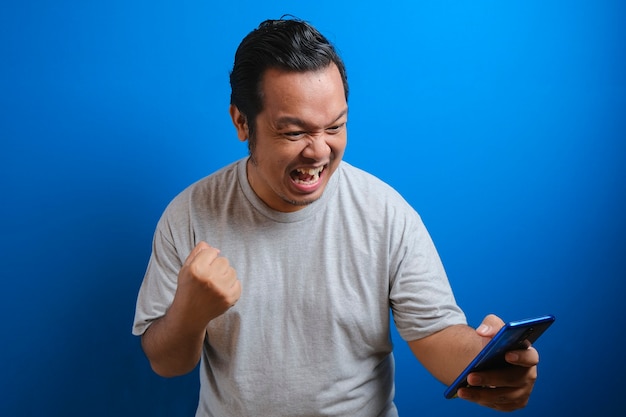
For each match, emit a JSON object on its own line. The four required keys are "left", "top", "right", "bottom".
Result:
{"left": 0, "top": 0, "right": 626, "bottom": 417}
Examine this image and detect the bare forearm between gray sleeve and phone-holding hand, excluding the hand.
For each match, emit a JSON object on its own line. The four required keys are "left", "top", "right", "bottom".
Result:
{"left": 409, "top": 325, "right": 486, "bottom": 385}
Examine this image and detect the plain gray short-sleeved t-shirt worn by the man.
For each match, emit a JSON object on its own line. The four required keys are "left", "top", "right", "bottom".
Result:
{"left": 133, "top": 159, "right": 465, "bottom": 417}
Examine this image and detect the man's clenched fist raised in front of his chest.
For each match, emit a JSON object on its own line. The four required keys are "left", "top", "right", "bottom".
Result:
{"left": 175, "top": 242, "right": 241, "bottom": 327}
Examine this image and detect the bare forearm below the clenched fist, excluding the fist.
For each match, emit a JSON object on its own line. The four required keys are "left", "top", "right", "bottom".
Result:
{"left": 141, "top": 302, "right": 205, "bottom": 377}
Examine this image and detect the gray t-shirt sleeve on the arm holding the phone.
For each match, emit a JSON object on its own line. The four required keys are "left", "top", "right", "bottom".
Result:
{"left": 390, "top": 213, "right": 467, "bottom": 341}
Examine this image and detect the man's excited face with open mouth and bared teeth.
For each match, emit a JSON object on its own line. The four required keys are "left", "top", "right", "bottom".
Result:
{"left": 231, "top": 64, "right": 348, "bottom": 212}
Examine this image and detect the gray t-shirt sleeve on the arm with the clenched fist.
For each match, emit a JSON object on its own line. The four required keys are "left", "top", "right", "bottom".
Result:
{"left": 132, "top": 216, "right": 184, "bottom": 336}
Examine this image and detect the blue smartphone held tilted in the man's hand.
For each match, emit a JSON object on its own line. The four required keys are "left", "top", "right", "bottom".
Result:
{"left": 444, "top": 315, "right": 555, "bottom": 399}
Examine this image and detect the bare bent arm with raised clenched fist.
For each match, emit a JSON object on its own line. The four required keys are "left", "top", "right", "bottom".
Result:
{"left": 141, "top": 242, "right": 241, "bottom": 377}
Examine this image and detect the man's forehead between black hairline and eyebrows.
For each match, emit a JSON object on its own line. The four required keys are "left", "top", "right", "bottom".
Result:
{"left": 259, "top": 64, "right": 347, "bottom": 124}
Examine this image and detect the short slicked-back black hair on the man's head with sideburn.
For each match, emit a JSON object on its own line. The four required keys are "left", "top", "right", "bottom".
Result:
{"left": 230, "top": 18, "right": 348, "bottom": 151}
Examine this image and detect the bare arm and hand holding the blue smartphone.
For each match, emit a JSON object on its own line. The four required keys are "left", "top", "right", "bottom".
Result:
{"left": 409, "top": 315, "right": 539, "bottom": 411}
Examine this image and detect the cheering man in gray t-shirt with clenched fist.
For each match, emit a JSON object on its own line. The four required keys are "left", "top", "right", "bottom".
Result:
{"left": 133, "top": 20, "right": 538, "bottom": 416}
